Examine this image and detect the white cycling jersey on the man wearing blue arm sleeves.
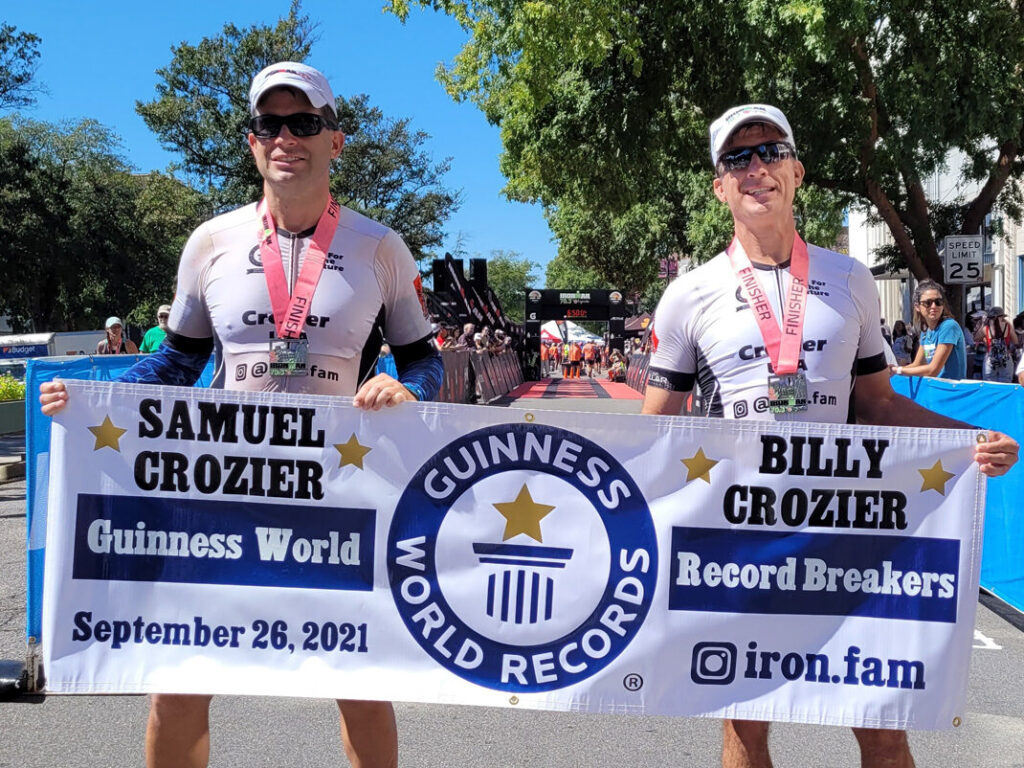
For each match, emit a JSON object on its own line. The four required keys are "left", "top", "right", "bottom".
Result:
{"left": 168, "top": 204, "right": 430, "bottom": 395}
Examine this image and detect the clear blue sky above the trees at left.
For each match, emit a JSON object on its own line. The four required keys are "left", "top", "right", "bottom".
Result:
{"left": 0, "top": 0, "right": 556, "bottom": 279}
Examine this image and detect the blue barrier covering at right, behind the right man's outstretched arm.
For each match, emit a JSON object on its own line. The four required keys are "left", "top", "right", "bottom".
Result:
{"left": 893, "top": 376, "right": 1024, "bottom": 610}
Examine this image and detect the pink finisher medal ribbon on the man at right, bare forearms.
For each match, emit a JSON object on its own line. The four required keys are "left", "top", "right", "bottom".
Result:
{"left": 726, "top": 234, "right": 809, "bottom": 376}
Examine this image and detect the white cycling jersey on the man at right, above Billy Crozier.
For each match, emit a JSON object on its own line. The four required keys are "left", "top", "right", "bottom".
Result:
{"left": 647, "top": 245, "right": 886, "bottom": 423}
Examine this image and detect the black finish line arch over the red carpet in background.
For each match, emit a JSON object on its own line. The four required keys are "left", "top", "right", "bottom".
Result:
{"left": 522, "top": 288, "right": 626, "bottom": 381}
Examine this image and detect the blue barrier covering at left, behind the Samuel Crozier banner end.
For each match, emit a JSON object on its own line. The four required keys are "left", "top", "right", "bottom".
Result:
{"left": 25, "top": 354, "right": 213, "bottom": 643}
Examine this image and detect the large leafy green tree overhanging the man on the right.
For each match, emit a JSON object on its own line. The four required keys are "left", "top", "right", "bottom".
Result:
{"left": 391, "top": 0, "right": 1024, "bottom": 319}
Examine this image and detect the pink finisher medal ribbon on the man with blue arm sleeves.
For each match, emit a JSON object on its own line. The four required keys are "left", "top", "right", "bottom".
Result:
{"left": 256, "top": 198, "right": 341, "bottom": 339}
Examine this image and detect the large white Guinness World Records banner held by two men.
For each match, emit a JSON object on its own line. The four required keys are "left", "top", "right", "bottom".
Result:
{"left": 43, "top": 381, "right": 984, "bottom": 728}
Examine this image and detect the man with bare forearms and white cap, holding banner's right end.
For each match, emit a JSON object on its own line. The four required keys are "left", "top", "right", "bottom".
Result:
{"left": 643, "top": 104, "right": 1018, "bottom": 768}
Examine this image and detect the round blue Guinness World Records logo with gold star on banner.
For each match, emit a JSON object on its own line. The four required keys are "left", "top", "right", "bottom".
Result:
{"left": 387, "top": 424, "right": 657, "bottom": 692}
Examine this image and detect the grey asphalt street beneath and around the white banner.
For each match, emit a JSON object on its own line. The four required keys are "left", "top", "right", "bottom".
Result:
{"left": 0, "top": 399, "right": 1024, "bottom": 768}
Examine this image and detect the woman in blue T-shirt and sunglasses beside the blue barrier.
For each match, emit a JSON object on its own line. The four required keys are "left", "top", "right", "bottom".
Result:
{"left": 893, "top": 280, "right": 967, "bottom": 379}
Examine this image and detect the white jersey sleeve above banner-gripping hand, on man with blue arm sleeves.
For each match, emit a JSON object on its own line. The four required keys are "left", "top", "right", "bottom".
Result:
{"left": 375, "top": 230, "right": 431, "bottom": 346}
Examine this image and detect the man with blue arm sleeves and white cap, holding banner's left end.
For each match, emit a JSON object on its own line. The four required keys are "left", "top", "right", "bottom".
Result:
{"left": 40, "top": 61, "right": 443, "bottom": 768}
